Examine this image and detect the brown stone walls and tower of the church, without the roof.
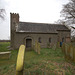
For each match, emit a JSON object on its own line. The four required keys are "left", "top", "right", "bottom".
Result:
{"left": 10, "top": 13, "right": 70, "bottom": 49}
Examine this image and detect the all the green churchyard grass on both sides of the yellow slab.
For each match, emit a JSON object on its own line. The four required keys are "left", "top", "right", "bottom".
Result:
{"left": 0, "top": 42, "right": 75, "bottom": 75}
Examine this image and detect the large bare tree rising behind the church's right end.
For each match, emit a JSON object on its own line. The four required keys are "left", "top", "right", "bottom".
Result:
{"left": 55, "top": 0, "right": 75, "bottom": 37}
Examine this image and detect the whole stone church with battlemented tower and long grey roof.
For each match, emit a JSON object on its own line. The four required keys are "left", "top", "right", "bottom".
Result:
{"left": 10, "top": 13, "right": 71, "bottom": 49}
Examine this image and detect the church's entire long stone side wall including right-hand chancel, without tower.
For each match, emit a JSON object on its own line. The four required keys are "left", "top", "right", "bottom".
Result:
{"left": 14, "top": 31, "right": 70, "bottom": 48}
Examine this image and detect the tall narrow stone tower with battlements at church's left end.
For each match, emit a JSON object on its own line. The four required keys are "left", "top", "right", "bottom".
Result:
{"left": 10, "top": 13, "right": 19, "bottom": 48}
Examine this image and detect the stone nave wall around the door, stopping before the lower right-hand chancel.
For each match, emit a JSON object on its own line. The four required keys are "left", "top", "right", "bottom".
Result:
{"left": 14, "top": 33, "right": 57, "bottom": 48}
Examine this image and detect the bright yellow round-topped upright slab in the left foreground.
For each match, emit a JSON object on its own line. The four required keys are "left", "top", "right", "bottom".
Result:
{"left": 16, "top": 45, "right": 25, "bottom": 75}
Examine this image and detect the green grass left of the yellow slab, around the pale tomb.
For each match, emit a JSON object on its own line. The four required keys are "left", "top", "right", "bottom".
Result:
{"left": 0, "top": 42, "right": 18, "bottom": 75}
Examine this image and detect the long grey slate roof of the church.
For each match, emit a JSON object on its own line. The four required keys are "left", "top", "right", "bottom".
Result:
{"left": 16, "top": 22, "right": 69, "bottom": 33}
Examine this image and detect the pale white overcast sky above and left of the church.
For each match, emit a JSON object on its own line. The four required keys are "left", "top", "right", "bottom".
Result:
{"left": 0, "top": 0, "right": 68, "bottom": 39}
